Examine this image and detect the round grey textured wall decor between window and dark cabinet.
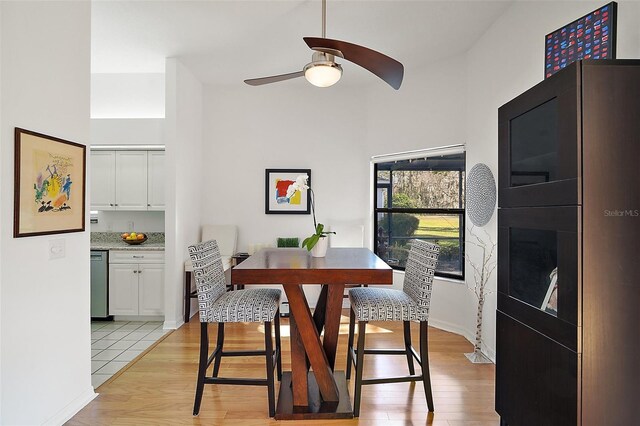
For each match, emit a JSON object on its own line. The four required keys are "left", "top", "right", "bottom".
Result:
{"left": 466, "top": 163, "right": 496, "bottom": 226}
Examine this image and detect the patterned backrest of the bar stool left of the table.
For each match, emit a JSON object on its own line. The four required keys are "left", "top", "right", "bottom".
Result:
{"left": 189, "top": 240, "right": 226, "bottom": 322}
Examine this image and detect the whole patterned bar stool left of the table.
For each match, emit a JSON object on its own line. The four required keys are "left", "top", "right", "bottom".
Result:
{"left": 189, "top": 240, "right": 282, "bottom": 417}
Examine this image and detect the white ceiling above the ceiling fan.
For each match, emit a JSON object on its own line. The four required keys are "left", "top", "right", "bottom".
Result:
{"left": 91, "top": 0, "right": 511, "bottom": 84}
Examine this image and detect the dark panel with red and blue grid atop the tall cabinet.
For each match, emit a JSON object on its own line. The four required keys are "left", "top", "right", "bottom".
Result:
{"left": 544, "top": 1, "right": 617, "bottom": 78}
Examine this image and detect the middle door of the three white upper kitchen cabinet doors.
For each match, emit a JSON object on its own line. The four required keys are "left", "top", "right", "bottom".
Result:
{"left": 116, "top": 151, "right": 147, "bottom": 210}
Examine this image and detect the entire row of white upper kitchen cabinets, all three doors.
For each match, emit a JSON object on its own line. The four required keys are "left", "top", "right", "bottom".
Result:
{"left": 91, "top": 150, "right": 165, "bottom": 210}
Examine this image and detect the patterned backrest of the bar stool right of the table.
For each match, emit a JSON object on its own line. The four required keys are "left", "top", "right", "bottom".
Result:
{"left": 402, "top": 240, "right": 440, "bottom": 319}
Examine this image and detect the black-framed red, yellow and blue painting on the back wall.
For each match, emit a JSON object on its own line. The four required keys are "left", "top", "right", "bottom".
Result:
{"left": 264, "top": 169, "right": 311, "bottom": 214}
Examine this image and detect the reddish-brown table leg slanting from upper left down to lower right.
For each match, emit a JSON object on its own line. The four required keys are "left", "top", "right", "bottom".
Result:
{"left": 284, "top": 284, "right": 339, "bottom": 401}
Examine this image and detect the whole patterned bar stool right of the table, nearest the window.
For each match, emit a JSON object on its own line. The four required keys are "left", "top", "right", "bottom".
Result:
{"left": 346, "top": 240, "right": 440, "bottom": 417}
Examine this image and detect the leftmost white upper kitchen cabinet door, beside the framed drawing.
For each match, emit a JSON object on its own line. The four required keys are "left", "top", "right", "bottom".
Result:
{"left": 91, "top": 151, "right": 116, "bottom": 210}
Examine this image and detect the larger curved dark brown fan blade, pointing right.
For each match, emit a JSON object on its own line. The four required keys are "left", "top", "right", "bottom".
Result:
{"left": 304, "top": 37, "right": 404, "bottom": 90}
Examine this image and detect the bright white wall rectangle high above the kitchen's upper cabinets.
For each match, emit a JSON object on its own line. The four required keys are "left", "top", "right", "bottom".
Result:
{"left": 91, "top": 73, "right": 165, "bottom": 118}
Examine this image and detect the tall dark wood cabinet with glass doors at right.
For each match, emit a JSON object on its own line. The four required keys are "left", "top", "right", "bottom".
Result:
{"left": 496, "top": 60, "right": 640, "bottom": 426}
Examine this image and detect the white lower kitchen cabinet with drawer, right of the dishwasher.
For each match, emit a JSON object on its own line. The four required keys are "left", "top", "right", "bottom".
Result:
{"left": 109, "top": 251, "right": 164, "bottom": 315}
